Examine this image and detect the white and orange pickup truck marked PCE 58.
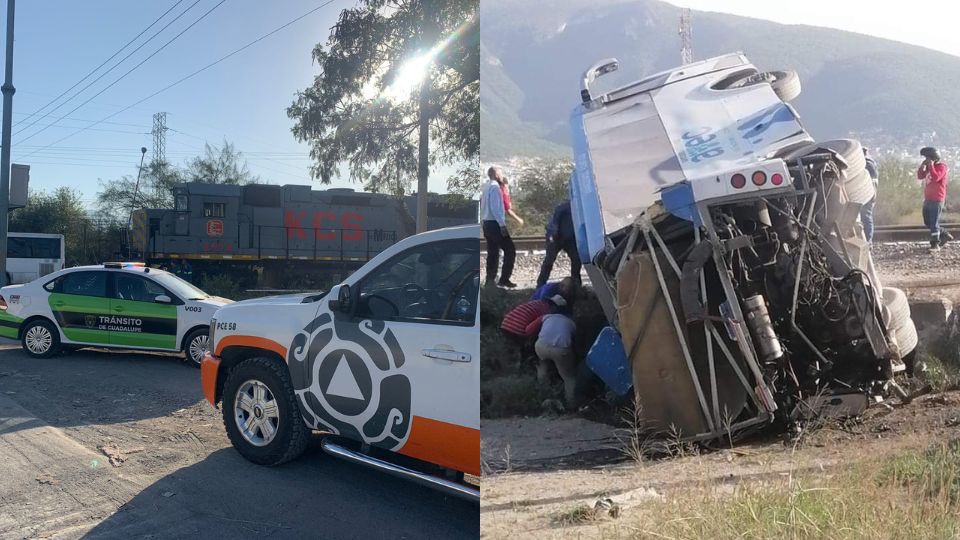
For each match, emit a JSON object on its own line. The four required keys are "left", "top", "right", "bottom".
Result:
{"left": 201, "top": 226, "right": 480, "bottom": 500}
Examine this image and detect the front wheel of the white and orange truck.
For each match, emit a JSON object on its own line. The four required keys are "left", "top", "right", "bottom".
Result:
{"left": 223, "top": 358, "right": 310, "bottom": 467}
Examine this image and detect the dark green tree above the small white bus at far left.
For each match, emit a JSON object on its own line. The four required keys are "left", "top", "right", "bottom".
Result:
{"left": 10, "top": 187, "right": 90, "bottom": 263}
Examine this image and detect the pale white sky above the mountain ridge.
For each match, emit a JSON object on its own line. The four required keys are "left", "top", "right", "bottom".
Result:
{"left": 668, "top": 0, "right": 960, "bottom": 56}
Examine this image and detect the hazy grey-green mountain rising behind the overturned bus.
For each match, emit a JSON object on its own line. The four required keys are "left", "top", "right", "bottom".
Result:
{"left": 480, "top": 0, "right": 960, "bottom": 161}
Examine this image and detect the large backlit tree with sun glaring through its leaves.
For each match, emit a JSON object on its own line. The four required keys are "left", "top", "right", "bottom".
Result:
{"left": 287, "top": 0, "right": 480, "bottom": 228}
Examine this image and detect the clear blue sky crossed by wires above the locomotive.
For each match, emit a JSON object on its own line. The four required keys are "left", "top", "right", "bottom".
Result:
{"left": 0, "top": 0, "right": 456, "bottom": 206}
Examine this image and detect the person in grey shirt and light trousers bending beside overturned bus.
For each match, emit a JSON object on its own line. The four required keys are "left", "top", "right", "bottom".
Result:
{"left": 534, "top": 304, "right": 577, "bottom": 407}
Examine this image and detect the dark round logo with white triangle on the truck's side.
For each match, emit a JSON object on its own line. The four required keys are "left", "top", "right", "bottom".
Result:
{"left": 287, "top": 313, "right": 411, "bottom": 450}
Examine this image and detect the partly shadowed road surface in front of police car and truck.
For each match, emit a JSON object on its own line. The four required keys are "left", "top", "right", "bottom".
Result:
{"left": 0, "top": 340, "right": 480, "bottom": 539}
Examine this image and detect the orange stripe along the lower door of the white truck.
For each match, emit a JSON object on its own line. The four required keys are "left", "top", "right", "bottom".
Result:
{"left": 399, "top": 416, "right": 480, "bottom": 475}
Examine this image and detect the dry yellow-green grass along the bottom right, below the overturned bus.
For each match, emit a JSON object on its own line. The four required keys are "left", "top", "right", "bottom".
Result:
{"left": 568, "top": 442, "right": 960, "bottom": 539}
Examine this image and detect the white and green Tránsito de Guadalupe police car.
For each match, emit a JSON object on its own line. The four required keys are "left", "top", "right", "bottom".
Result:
{"left": 0, "top": 263, "right": 231, "bottom": 366}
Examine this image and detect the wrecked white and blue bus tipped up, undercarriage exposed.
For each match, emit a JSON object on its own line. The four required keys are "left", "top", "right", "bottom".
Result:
{"left": 570, "top": 54, "right": 917, "bottom": 440}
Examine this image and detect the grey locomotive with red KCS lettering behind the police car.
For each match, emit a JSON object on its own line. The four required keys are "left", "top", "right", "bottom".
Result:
{"left": 131, "top": 182, "right": 478, "bottom": 288}
